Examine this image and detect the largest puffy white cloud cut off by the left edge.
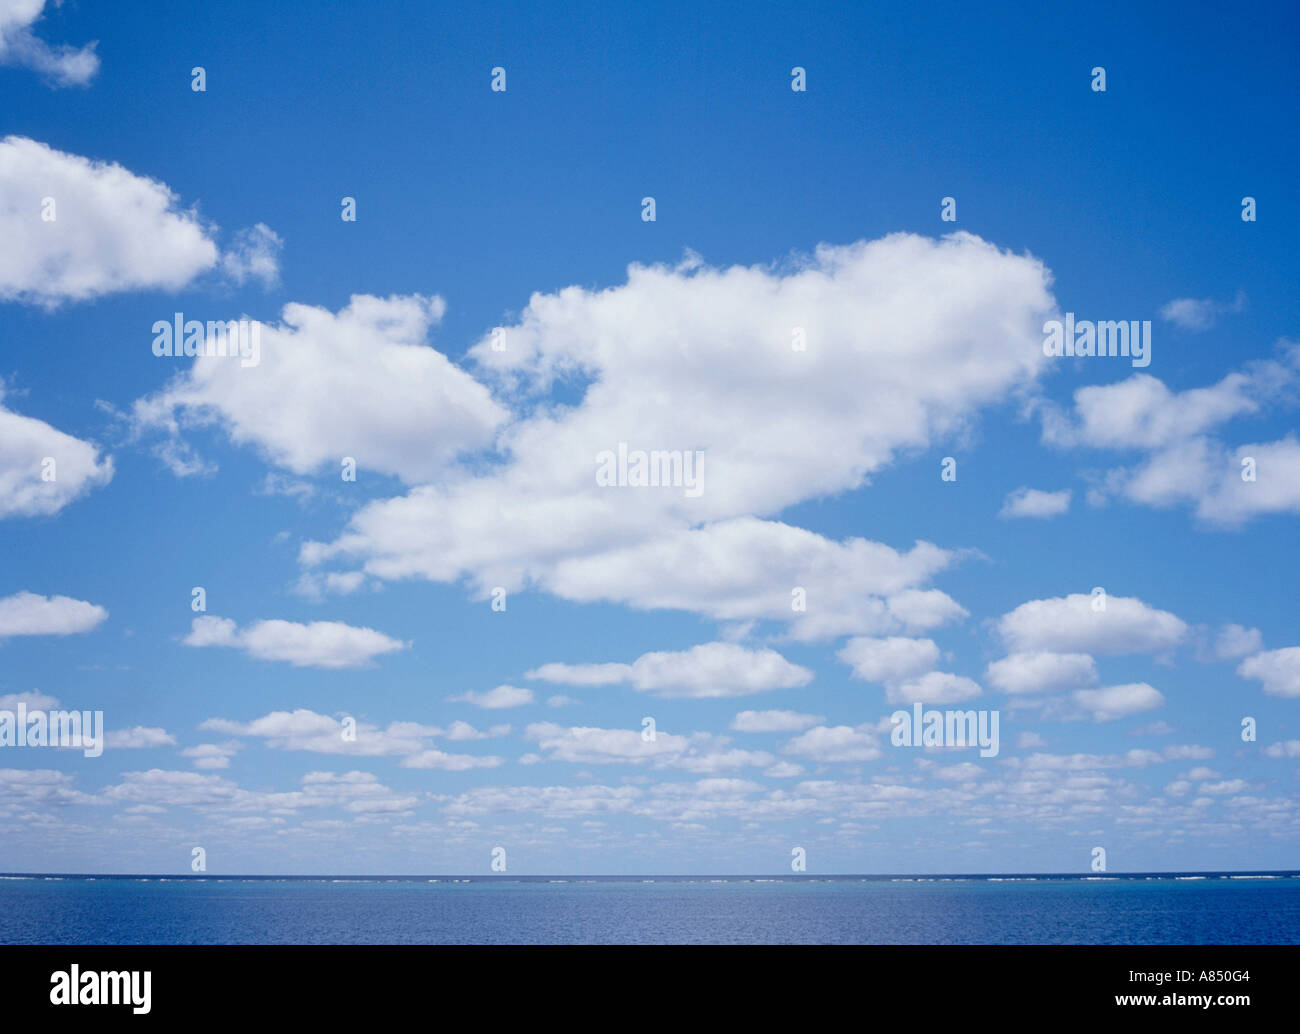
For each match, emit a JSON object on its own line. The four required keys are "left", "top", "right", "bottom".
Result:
{"left": 0, "top": 137, "right": 218, "bottom": 303}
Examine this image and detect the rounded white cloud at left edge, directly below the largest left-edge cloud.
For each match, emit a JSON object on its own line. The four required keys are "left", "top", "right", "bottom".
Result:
{"left": 0, "top": 384, "right": 113, "bottom": 519}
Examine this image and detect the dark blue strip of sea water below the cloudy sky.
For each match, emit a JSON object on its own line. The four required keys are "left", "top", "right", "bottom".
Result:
{"left": 0, "top": 873, "right": 1300, "bottom": 944}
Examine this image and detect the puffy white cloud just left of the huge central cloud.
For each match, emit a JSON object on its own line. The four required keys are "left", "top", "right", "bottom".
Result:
{"left": 131, "top": 295, "right": 506, "bottom": 483}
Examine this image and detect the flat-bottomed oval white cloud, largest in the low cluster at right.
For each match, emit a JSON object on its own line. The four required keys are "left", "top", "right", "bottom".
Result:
{"left": 997, "top": 593, "right": 1188, "bottom": 654}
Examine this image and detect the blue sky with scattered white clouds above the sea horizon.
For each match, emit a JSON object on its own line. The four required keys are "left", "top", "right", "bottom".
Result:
{"left": 0, "top": 0, "right": 1300, "bottom": 873}
